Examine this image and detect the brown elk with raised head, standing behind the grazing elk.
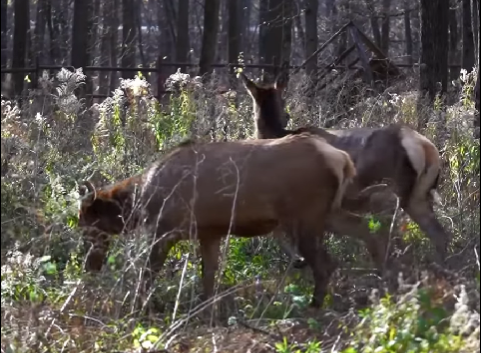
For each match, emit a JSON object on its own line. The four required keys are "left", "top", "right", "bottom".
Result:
{"left": 240, "top": 74, "right": 449, "bottom": 270}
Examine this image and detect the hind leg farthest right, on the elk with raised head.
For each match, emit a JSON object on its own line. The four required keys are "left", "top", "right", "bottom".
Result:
{"left": 406, "top": 200, "right": 449, "bottom": 264}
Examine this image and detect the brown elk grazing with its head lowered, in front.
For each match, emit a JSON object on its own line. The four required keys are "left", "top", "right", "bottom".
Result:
{"left": 79, "top": 134, "right": 355, "bottom": 306}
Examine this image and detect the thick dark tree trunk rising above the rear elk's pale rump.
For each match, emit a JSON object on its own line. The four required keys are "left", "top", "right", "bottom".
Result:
{"left": 418, "top": 0, "right": 449, "bottom": 129}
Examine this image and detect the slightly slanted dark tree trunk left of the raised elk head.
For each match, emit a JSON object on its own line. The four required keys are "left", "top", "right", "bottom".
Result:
{"left": 199, "top": 0, "right": 220, "bottom": 76}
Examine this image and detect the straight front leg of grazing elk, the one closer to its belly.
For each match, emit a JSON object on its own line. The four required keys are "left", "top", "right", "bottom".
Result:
{"left": 200, "top": 237, "right": 221, "bottom": 300}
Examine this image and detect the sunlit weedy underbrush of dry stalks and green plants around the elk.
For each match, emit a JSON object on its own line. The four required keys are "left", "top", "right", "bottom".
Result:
{"left": 1, "top": 70, "right": 480, "bottom": 353}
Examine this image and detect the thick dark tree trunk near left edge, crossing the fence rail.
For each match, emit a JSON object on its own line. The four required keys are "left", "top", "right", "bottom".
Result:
{"left": 12, "top": 0, "right": 30, "bottom": 95}
